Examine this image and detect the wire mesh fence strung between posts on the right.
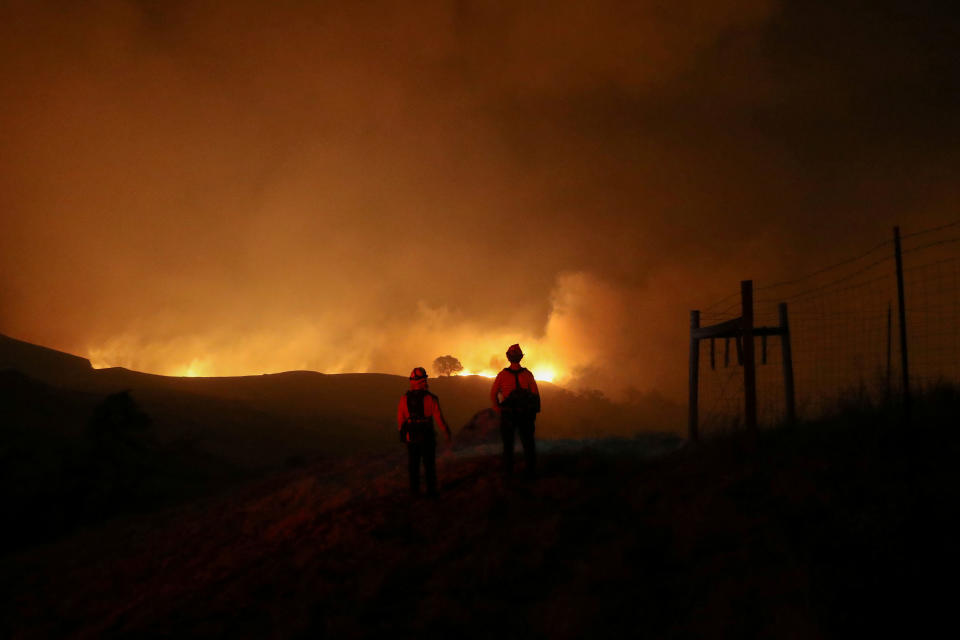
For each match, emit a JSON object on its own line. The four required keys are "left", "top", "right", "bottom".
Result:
{"left": 699, "top": 220, "right": 960, "bottom": 433}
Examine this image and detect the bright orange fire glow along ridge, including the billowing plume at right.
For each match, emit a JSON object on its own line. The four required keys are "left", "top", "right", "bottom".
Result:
{"left": 84, "top": 273, "right": 627, "bottom": 389}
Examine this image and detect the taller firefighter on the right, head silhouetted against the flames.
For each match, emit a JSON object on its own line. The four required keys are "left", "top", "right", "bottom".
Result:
{"left": 490, "top": 344, "right": 540, "bottom": 477}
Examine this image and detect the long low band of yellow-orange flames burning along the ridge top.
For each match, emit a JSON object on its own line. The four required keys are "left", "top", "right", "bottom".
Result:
{"left": 86, "top": 309, "right": 571, "bottom": 384}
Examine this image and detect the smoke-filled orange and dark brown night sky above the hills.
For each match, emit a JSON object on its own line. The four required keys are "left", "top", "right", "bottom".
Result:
{"left": 0, "top": 0, "right": 960, "bottom": 397}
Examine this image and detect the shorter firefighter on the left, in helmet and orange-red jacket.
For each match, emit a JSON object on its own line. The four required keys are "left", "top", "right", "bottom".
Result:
{"left": 397, "top": 367, "right": 450, "bottom": 496}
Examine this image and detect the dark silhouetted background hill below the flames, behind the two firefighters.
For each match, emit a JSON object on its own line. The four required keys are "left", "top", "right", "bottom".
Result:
{"left": 0, "top": 336, "right": 679, "bottom": 554}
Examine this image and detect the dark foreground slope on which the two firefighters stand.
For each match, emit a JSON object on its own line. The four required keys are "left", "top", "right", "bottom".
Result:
{"left": 0, "top": 397, "right": 960, "bottom": 638}
